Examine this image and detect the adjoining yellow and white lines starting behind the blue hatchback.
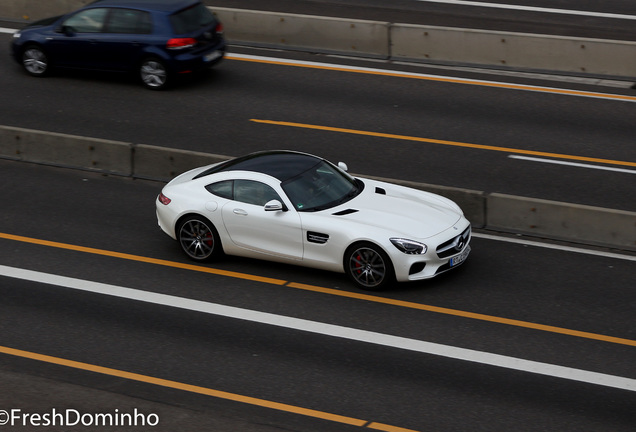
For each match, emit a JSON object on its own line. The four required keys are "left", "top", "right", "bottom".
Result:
{"left": 226, "top": 54, "right": 636, "bottom": 102}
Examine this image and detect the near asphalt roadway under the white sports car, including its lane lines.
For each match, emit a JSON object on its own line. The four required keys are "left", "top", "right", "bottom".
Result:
{"left": 0, "top": 157, "right": 636, "bottom": 432}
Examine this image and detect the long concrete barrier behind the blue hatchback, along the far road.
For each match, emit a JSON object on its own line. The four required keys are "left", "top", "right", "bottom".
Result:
{"left": 0, "top": 0, "right": 636, "bottom": 79}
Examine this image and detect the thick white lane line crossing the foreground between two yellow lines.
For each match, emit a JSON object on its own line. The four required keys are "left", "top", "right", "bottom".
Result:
{"left": 0, "top": 266, "right": 636, "bottom": 391}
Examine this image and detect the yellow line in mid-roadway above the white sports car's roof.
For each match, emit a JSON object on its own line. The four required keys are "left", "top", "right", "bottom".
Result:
{"left": 250, "top": 119, "right": 636, "bottom": 167}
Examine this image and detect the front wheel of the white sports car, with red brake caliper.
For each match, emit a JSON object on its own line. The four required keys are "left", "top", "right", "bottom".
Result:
{"left": 344, "top": 242, "right": 395, "bottom": 291}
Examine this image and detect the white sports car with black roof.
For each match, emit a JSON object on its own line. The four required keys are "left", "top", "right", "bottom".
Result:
{"left": 156, "top": 150, "right": 471, "bottom": 290}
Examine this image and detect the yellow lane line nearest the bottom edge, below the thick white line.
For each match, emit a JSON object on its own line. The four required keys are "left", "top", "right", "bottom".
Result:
{"left": 0, "top": 346, "right": 416, "bottom": 432}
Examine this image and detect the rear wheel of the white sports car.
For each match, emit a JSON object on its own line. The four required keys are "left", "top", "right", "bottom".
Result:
{"left": 177, "top": 215, "right": 223, "bottom": 262}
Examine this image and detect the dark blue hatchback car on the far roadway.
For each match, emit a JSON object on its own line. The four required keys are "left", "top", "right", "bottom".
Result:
{"left": 12, "top": 0, "right": 226, "bottom": 90}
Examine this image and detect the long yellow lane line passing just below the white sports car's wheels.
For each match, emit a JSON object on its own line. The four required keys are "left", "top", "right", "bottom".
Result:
{"left": 0, "top": 233, "right": 636, "bottom": 346}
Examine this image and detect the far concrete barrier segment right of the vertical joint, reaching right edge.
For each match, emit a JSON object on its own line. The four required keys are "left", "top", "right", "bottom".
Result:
{"left": 391, "top": 24, "right": 636, "bottom": 77}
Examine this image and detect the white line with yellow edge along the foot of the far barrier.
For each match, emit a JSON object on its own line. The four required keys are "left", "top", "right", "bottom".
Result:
{"left": 231, "top": 53, "right": 636, "bottom": 102}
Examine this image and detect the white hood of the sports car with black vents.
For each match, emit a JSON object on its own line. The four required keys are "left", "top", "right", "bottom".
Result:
{"left": 329, "top": 180, "right": 462, "bottom": 240}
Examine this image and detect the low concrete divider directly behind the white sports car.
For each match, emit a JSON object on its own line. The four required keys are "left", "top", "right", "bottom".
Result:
{"left": 0, "top": 126, "right": 636, "bottom": 251}
